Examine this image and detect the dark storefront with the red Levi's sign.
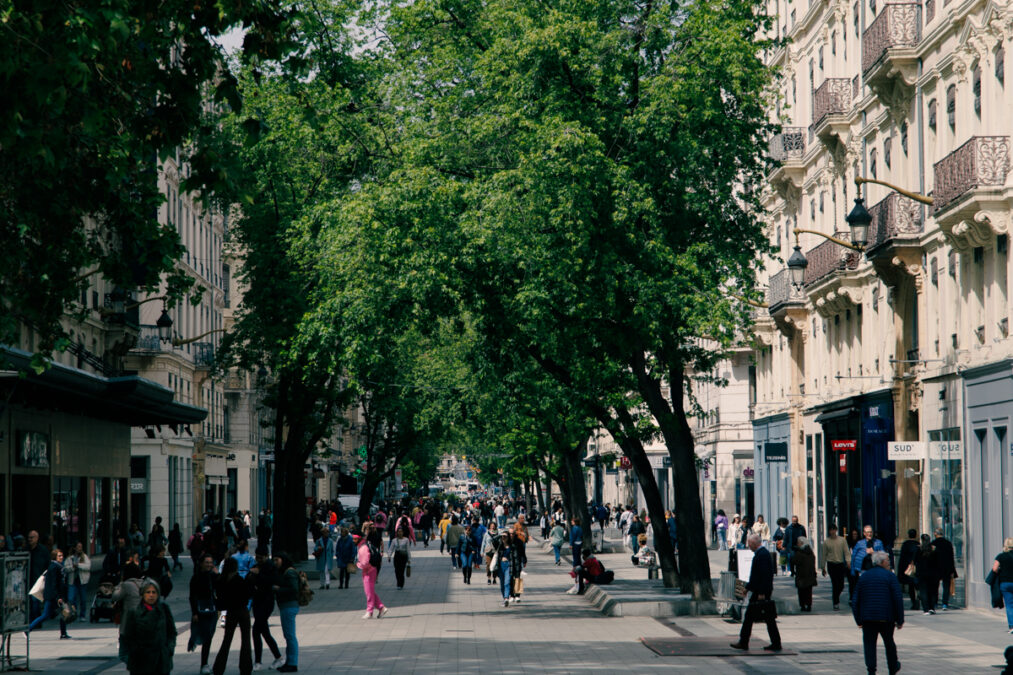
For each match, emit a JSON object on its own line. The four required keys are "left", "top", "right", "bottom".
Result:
{"left": 815, "top": 391, "right": 897, "bottom": 547}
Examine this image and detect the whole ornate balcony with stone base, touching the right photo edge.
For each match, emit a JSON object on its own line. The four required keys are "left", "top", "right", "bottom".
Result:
{"left": 933, "top": 136, "right": 1010, "bottom": 250}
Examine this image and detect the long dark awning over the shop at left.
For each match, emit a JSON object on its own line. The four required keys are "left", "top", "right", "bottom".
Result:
{"left": 0, "top": 346, "right": 208, "bottom": 427}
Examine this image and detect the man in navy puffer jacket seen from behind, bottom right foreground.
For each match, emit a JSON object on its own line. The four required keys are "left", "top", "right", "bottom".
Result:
{"left": 851, "top": 550, "right": 904, "bottom": 675}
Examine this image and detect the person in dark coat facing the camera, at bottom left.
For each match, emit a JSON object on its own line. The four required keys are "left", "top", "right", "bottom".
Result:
{"left": 121, "top": 579, "right": 176, "bottom": 675}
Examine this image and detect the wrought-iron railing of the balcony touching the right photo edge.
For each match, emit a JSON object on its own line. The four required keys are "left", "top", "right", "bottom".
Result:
{"left": 933, "top": 136, "right": 1010, "bottom": 213}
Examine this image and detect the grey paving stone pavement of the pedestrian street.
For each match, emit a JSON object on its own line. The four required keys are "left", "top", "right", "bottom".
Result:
{"left": 19, "top": 543, "right": 1011, "bottom": 675}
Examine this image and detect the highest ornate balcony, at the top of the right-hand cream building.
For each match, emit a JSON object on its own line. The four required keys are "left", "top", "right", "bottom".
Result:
{"left": 862, "top": 2, "right": 922, "bottom": 120}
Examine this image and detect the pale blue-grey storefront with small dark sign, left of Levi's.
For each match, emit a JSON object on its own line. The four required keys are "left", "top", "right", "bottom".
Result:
{"left": 753, "top": 413, "right": 794, "bottom": 530}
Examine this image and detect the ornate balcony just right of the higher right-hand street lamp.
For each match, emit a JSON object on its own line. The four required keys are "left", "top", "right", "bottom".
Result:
{"left": 865, "top": 193, "right": 923, "bottom": 287}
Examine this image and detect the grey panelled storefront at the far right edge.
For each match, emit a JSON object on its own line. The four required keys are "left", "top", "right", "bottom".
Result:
{"left": 960, "top": 360, "right": 1013, "bottom": 607}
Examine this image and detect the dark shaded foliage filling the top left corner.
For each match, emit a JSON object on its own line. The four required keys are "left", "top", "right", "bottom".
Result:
{"left": 0, "top": 0, "right": 290, "bottom": 354}
